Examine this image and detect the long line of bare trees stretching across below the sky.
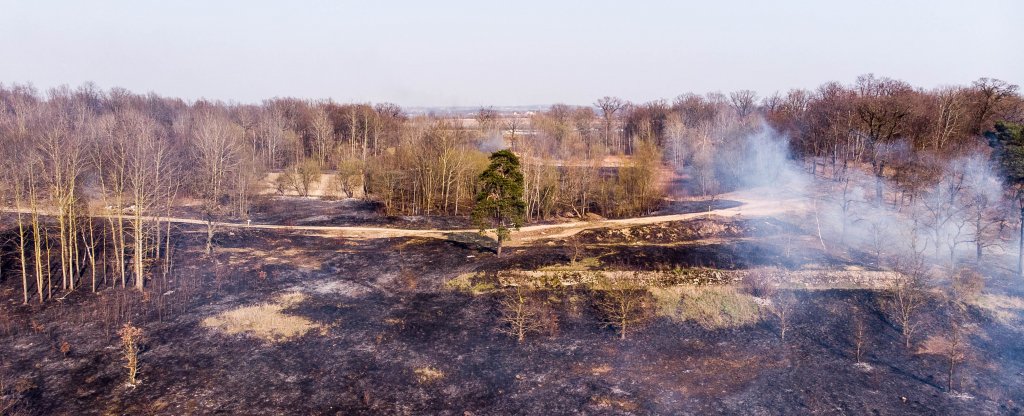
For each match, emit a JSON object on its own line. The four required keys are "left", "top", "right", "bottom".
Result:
{"left": 0, "top": 75, "right": 1024, "bottom": 302}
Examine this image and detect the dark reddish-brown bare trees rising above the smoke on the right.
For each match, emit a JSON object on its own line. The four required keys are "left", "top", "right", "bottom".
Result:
{"left": 762, "top": 75, "right": 1024, "bottom": 195}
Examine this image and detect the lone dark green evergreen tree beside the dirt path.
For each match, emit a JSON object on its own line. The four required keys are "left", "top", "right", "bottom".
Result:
{"left": 473, "top": 150, "right": 526, "bottom": 255}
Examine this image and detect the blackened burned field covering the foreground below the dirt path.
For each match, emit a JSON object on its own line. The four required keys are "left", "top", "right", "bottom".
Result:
{"left": 0, "top": 208, "right": 1024, "bottom": 415}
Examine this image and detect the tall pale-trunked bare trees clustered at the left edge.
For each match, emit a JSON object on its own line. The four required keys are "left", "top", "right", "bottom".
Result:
{"left": 0, "top": 85, "right": 261, "bottom": 303}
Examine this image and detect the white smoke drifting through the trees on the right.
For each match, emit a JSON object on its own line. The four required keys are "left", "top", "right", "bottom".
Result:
{"left": 716, "top": 123, "right": 1015, "bottom": 269}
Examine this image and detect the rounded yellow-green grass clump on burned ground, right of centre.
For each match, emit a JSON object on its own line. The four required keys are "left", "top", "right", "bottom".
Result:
{"left": 648, "top": 286, "right": 761, "bottom": 329}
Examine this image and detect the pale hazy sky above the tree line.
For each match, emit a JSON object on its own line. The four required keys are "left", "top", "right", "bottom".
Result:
{"left": 0, "top": 0, "right": 1024, "bottom": 106}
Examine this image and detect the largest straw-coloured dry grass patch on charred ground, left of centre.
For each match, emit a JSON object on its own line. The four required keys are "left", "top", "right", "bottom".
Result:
{"left": 203, "top": 292, "right": 325, "bottom": 342}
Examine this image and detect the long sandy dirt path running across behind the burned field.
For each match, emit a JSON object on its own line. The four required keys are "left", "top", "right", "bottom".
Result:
{"left": 3, "top": 190, "right": 806, "bottom": 246}
